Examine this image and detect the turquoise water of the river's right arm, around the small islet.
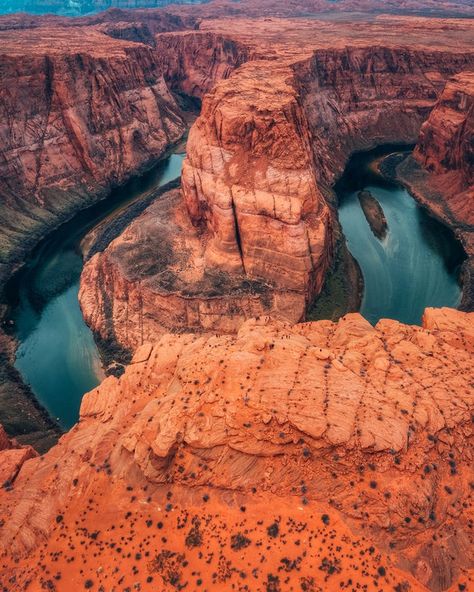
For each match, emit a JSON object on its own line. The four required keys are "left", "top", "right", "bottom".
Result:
{"left": 338, "top": 149, "right": 463, "bottom": 324}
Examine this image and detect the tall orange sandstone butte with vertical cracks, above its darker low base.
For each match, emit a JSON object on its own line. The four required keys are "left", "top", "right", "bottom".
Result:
{"left": 182, "top": 62, "right": 331, "bottom": 301}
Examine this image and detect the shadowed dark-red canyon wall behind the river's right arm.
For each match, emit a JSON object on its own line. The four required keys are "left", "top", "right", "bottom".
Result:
{"left": 295, "top": 45, "right": 474, "bottom": 184}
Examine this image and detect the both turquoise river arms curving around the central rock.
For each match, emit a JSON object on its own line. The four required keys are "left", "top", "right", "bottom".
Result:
{"left": 2, "top": 145, "right": 463, "bottom": 429}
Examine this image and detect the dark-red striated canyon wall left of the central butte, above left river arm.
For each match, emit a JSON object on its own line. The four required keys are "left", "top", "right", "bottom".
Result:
{"left": 0, "top": 27, "right": 185, "bottom": 284}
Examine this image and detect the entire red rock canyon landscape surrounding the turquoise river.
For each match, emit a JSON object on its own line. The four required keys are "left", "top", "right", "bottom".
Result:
{"left": 0, "top": 0, "right": 474, "bottom": 592}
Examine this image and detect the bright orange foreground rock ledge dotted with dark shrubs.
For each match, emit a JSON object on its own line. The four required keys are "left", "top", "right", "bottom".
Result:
{"left": 0, "top": 309, "right": 474, "bottom": 591}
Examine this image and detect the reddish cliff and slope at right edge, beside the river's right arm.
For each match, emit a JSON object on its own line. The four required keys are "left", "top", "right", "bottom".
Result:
{"left": 398, "top": 71, "right": 474, "bottom": 309}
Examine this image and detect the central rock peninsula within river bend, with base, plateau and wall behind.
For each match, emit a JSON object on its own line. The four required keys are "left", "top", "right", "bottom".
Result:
{"left": 80, "top": 19, "right": 474, "bottom": 350}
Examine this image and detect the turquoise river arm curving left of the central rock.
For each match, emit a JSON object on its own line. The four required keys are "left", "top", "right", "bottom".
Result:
{"left": 9, "top": 154, "right": 184, "bottom": 429}
